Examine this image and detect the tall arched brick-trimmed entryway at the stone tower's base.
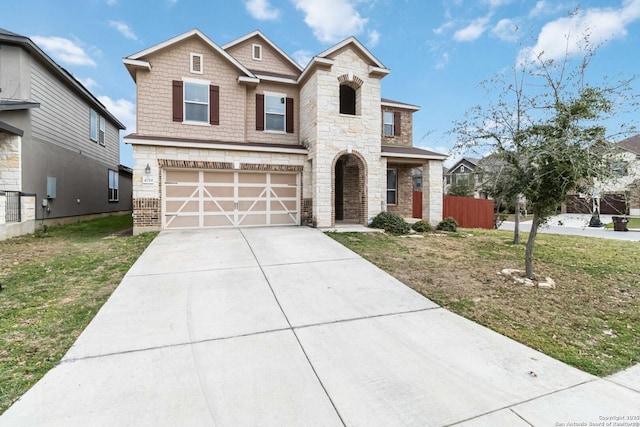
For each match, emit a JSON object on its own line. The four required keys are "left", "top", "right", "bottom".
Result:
{"left": 332, "top": 153, "right": 367, "bottom": 224}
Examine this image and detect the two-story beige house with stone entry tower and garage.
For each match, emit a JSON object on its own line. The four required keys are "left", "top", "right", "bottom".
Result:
{"left": 124, "top": 29, "right": 445, "bottom": 232}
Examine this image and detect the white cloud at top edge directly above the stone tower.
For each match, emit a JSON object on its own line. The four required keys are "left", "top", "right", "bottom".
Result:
{"left": 291, "top": 0, "right": 369, "bottom": 43}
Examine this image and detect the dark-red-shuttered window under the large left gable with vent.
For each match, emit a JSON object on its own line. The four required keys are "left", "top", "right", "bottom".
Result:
{"left": 172, "top": 79, "right": 220, "bottom": 125}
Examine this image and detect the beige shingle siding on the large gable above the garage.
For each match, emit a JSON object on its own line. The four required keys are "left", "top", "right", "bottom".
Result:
{"left": 136, "top": 38, "right": 246, "bottom": 141}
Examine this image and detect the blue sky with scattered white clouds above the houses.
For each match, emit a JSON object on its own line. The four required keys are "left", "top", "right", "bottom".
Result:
{"left": 5, "top": 0, "right": 640, "bottom": 166}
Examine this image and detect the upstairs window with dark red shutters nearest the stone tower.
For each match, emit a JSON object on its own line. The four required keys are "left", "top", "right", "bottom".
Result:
{"left": 256, "top": 93, "right": 293, "bottom": 133}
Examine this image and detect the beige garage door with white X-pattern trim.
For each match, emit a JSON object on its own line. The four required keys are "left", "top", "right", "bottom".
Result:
{"left": 162, "top": 170, "right": 300, "bottom": 229}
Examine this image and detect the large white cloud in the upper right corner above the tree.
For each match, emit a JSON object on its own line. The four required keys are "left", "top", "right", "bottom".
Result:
{"left": 519, "top": 0, "right": 640, "bottom": 60}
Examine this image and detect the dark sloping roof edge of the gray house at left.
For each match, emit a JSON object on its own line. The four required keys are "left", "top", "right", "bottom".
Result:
{"left": 0, "top": 28, "right": 126, "bottom": 129}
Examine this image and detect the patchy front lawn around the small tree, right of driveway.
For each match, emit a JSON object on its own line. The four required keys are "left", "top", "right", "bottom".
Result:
{"left": 328, "top": 230, "right": 640, "bottom": 376}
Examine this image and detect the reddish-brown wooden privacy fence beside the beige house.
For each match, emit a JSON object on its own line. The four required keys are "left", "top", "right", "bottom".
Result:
{"left": 442, "top": 196, "right": 494, "bottom": 229}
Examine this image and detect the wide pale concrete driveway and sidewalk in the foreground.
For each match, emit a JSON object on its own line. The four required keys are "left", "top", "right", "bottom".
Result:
{"left": 0, "top": 227, "right": 640, "bottom": 427}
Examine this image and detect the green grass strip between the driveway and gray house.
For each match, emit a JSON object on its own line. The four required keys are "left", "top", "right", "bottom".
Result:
{"left": 0, "top": 215, "right": 155, "bottom": 413}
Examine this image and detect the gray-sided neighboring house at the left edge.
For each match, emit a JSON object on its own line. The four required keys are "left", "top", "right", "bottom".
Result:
{"left": 0, "top": 29, "right": 132, "bottom": 238}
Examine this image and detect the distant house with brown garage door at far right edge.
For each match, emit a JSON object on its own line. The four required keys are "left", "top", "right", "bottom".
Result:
{"left": 566, "top": 134, "right": 640, "bottom": 216}
